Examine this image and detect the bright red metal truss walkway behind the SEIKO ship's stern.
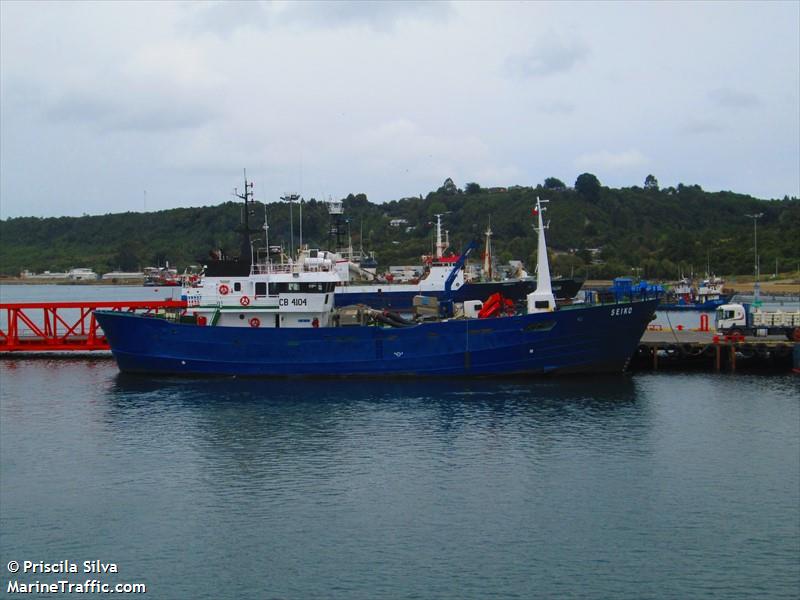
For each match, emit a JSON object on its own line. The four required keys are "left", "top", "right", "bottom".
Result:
{"left": 0, "top": 300, "right": 186, "bottom": 352}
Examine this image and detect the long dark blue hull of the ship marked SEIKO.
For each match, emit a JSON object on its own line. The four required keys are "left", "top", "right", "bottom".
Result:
{"left": 95, "top": 300, "right": 657, "bottom": 376}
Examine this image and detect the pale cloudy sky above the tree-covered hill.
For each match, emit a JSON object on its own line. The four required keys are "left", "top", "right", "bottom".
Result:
{"left": 0, "top": 1, "right": 800, "bottom": 218}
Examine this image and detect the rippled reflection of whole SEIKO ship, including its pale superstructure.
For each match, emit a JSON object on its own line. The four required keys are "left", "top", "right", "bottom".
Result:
{"left": 108, "top": 374, "right": 651, "bottom": 492}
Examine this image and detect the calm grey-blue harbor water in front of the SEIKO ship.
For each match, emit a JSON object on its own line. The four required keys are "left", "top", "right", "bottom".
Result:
{"left": 0, "top": 292, "right": 800, "bottom": 599}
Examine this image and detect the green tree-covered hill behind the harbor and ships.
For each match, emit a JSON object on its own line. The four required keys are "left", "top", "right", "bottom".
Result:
{"left": 0, "top": 173, "right": 800, "bottom": 279}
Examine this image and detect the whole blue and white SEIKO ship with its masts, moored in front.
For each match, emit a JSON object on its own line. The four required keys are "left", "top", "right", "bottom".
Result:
{"left": 96, "top": 180, "right": 657, "bottom": 376}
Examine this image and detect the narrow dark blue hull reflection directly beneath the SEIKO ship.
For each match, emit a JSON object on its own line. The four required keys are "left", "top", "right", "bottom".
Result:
{"left": 108, "top": 373, "right": 637, "bottom": 420}
